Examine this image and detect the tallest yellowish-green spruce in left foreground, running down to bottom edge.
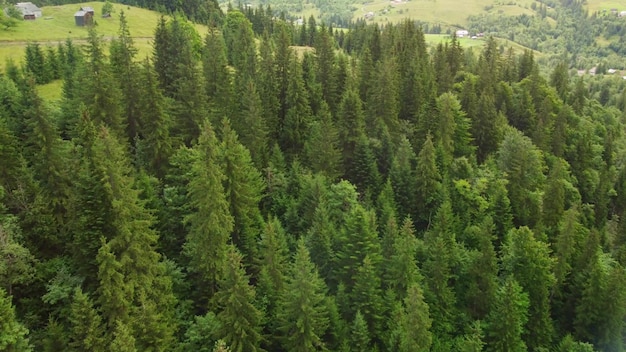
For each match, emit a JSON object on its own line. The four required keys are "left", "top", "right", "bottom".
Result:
{"left": 96, "top": 129, "right": 176, "bottom": 350}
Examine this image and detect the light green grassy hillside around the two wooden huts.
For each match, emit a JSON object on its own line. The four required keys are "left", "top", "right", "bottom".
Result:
{"left": 0, "top": 2, "right": 207, "bottom": 69}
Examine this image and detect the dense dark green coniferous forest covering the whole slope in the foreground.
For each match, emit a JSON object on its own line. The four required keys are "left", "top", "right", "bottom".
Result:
{"left": 0, "top": 2, "right": 626, "bottom": 352}
